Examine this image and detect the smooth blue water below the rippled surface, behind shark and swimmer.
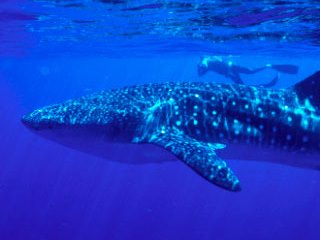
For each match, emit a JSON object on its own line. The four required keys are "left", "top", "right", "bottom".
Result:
{"left": 0, "top": 55, "right": 320, "bottom": 240}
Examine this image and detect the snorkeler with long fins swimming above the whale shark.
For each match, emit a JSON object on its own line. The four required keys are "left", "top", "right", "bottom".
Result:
{"left": 198, "top": 56, "right": 299, "bottom": 87}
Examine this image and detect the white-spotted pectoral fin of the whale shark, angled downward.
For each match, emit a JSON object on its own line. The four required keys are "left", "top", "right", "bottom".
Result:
{"left": 149, "top": 132, "right": 240, "bottom": 191}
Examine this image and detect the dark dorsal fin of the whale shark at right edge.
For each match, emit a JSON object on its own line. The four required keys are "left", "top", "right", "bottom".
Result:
{"left": 293, "top": 71, "right": 320, "bottom": 110}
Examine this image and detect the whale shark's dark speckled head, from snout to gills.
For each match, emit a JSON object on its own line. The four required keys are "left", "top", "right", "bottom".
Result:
{"left": 22, "top": 89, "right": 147, "bottom": 142}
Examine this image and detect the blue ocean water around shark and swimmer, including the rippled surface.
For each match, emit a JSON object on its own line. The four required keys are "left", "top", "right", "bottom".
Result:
{"left": 0, "top": 0, "right": 320, "bottom": 240}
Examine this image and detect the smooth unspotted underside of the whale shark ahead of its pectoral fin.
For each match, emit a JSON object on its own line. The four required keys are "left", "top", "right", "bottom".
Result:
{"left": 36, "top": 128, "right": 177, "bottom": 164}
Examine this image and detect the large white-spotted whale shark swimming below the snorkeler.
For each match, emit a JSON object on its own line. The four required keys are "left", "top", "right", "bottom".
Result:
{"left": 22, "top": 71, "right": 320, "bottom": 191}
